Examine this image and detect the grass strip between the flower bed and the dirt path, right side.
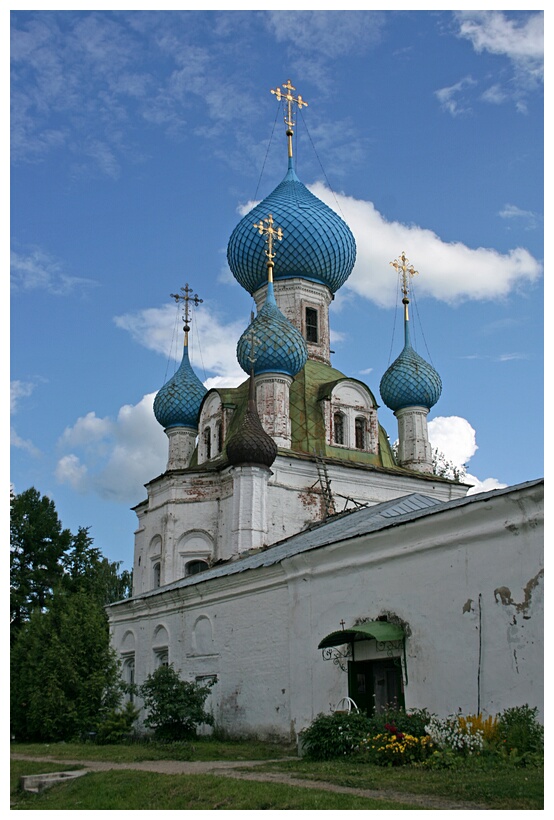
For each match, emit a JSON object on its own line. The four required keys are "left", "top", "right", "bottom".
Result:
{"left": 251, "top": 758, "right": 544, "bottom": 810}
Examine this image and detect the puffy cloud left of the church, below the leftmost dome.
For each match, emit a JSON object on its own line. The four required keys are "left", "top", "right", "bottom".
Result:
{"left": 56, "top": 393, "right": 167, "bottom": 503}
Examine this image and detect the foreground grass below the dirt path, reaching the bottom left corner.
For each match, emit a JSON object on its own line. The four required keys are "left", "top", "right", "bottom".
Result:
{"left": 11, "top": 761, "right": 416, "bottom": 811}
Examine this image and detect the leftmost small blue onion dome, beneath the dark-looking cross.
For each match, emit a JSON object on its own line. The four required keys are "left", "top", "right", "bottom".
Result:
{"left": 154, "top": 345, "right": 207, "bottom": 430}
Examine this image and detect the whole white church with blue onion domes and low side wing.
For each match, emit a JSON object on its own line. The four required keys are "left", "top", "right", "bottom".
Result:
{"left": 108, "top": 80, "right": 544, "bottom": 740}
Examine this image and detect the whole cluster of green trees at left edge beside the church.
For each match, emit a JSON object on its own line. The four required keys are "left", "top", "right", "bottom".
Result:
{"left": 10, "top": 488, "right": 131, "bottom": 741}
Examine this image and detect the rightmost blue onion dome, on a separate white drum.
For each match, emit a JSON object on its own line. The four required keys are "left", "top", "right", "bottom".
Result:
{"left": 379, "top": 324, "right": 442, "bottom": 412}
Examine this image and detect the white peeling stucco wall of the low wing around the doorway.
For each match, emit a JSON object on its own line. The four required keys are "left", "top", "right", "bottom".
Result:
{"left": 110, "top": 485, "right": 543, "bottom": 737}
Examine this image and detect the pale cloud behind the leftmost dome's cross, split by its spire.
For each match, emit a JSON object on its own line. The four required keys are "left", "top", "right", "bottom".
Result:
{"left": 114, "top": 305, "right": 249, "bottom": 381}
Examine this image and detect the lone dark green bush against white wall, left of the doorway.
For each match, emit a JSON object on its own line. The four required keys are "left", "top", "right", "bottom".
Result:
{"left": 139, "top": 664, "right": 214, "bottom": 740}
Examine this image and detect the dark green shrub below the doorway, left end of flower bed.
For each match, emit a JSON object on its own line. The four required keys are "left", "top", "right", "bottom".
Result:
{"left": 300, "top": 712, "right": 371, "bottom": 760}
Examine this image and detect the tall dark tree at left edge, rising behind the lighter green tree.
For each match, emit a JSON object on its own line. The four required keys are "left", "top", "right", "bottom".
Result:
{"left": 10, "top": 487, "right": 72, "bottom": 632}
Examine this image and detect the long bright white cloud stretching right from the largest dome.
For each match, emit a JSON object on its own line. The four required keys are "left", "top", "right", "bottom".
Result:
{"left": 309, "top": 182, "right": 542, "bottom": 307}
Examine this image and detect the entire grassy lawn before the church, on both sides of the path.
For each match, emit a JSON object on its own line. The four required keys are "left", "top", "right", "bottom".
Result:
{"left": 11, "top": 738, "right": 543, "bottom": 811}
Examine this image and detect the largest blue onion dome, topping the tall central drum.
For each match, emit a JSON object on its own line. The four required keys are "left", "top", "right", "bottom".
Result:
{"left": 227, "top": 159, "right": 356, "bottom": 293}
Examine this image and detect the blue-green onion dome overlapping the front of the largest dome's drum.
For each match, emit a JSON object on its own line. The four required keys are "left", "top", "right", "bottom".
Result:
{"left": 237, "top": 278, "right": 308, "bottom": 376}
